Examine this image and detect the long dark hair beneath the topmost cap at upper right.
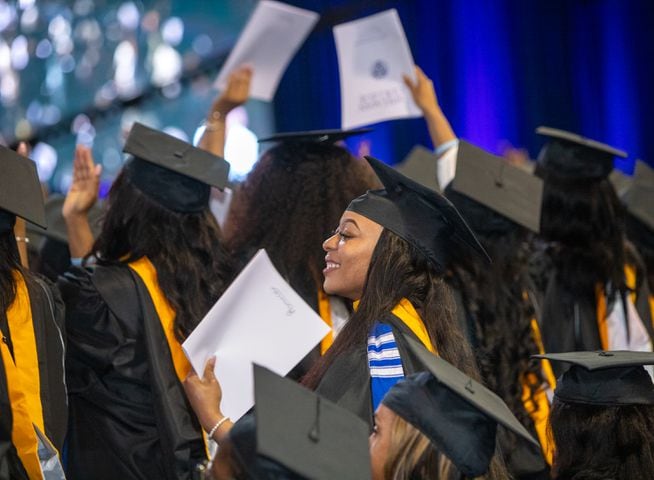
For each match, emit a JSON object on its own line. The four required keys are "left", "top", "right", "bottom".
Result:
{"left": 541, "top": 172, "right": 625, "bottom": 302}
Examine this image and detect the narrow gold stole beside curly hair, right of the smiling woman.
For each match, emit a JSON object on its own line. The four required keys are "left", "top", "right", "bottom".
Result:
{"left": 522, "top": 318, "right": 556, "bottom": 465}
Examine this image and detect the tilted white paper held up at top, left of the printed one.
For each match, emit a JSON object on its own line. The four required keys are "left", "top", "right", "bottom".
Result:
{"left": 214, "top": 0, "right": 319, "bottom": 102}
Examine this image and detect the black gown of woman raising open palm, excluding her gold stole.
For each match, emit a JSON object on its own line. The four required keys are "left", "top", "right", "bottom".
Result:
{"left": 59, "top": 266, "right": 206, "bottom": 480}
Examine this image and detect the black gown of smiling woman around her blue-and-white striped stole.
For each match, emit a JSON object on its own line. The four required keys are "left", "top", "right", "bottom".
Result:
{"left": 316, "top": 313, "right": 422, "bottom": 431}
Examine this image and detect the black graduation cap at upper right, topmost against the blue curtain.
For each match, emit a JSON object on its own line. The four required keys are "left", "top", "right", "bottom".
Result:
{"left": 536, "top": 127, "right": 627, "bottom": 179}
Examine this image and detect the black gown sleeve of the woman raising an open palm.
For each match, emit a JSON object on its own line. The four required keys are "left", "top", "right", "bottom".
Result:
{"left": 59, "top": 267, "right": 167, "bottom": 479}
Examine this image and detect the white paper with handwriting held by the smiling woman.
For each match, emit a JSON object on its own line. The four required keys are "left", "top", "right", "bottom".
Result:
{"left": 182, "top": 250, "right": 329, "bottom": 421}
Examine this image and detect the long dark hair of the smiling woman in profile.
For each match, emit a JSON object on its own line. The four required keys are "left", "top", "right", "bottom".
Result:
{"left": 302, "top": 229, "right": 479, "bottom": 388}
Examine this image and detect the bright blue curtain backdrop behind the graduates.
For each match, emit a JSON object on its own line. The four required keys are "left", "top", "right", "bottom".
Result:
{"left": 275, "top": 0, "right": 654, "bottom": 171}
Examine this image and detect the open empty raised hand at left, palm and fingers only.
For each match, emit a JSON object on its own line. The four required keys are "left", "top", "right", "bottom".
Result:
{"left": 62, "top": 145, "right": 102, "bottom": 219}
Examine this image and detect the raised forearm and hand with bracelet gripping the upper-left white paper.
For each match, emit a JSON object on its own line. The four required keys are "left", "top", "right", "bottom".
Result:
{"left": 198, "top": 67, "right": 252, "bottom": 157}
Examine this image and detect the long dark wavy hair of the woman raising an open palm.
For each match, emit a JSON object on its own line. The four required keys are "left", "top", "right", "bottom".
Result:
{"left": 92, "top": 170, "right": 233, "bottom": 341}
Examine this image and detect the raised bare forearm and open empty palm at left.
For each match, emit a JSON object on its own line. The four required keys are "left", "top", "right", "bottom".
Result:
{"left": 62, "top": 145, "right": 102, "bottom": 258}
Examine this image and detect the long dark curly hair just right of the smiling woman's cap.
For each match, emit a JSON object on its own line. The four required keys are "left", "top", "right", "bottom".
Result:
{"left": 447, "top": 191, "right": 546, "bottom": 454}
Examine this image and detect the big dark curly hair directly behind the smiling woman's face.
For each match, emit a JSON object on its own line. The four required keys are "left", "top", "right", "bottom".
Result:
{"left": 225, "top": 142, "right": 378, "bottom": 302}
